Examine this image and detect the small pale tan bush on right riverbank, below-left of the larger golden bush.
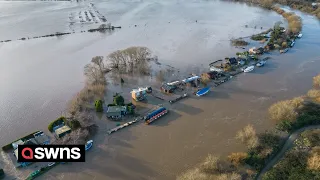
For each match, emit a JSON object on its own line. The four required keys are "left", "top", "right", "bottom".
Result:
{"left": 236, "top": 124, "right": 258, "bottom": 148}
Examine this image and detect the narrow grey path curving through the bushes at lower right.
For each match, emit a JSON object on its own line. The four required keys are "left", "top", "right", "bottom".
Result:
{"left": 256, "top": 125, "right": 320, "bottom": 180}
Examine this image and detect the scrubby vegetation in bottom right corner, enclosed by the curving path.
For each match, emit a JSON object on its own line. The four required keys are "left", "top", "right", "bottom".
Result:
{"left": 262, "top": 129, "right": 320, "bottom": 180}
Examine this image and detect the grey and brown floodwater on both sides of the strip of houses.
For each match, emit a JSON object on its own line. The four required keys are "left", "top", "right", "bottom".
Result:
{"left": 0, "top": 0, "right": 320, "bottom": 180}
